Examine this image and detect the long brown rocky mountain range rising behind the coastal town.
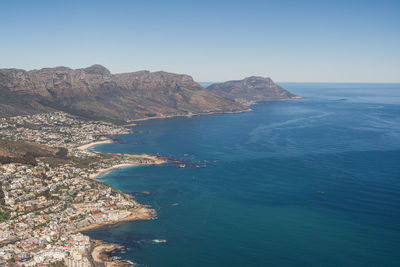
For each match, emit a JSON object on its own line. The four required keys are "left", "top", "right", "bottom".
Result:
{"left": 0, "top": 65, "right": 247, "bottom": 122}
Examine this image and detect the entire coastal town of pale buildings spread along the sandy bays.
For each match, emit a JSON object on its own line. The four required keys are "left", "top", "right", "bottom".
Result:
{"left": 0, "top": 112, "right": 165, "bottom": 266}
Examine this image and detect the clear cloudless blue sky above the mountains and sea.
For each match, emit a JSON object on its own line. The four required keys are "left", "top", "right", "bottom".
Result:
{"left": 0, "top": 0, "right": 400, "bottom": 82}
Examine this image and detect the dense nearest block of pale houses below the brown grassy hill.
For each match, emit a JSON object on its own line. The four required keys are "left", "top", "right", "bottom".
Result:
{"left": 0, "top": 159, "right": 148, "bottom": 266}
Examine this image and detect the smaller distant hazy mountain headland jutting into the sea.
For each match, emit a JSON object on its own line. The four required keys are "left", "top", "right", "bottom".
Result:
{"left": 207, "top": 76, "right": 299, "bottom": 105}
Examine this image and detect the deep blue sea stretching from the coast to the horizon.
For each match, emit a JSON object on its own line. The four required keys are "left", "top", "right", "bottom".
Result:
{"left": 85, "top": 83, "right": 400, "bottom": 267}
